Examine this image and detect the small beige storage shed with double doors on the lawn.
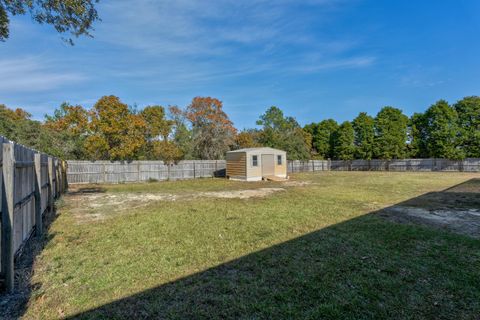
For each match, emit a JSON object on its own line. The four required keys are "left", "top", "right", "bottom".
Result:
{"left": 227, "top": 148, "right": 287, "bottom": 181}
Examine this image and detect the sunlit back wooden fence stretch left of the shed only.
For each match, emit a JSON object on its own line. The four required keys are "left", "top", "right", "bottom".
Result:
{"left": 67, "top": 160, "right": 226, "bottom": 184}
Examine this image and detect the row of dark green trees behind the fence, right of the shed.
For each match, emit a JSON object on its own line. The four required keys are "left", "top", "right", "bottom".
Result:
{"left": 304, "top": 96, "right": 480, "bottom": 160}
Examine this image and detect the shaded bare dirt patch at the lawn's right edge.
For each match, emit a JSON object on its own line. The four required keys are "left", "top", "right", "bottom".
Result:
{"left": 381, "top": 179, "right": 480, "bottom": 238}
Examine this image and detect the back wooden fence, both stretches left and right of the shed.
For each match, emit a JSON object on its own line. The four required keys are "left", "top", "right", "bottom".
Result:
{"left": 67, "top": 159, "right": 480, "bottom": 184}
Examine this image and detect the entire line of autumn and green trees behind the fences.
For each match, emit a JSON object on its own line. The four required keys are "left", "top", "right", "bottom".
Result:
{"left": 0, "top": 96, "right": 480, "bottom": 162}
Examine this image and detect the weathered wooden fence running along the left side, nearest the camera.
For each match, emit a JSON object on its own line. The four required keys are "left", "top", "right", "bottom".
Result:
{"left": 0, "top": 136, "right": 67, "bottom": 292}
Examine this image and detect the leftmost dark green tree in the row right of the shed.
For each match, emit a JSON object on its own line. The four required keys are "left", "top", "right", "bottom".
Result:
{"left": 304, "top": 119, "right": 338, "bottom": 159}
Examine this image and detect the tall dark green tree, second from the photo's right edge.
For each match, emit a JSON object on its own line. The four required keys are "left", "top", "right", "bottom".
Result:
{"left": 423, "top": 100, "right": 463, "bottom": 159}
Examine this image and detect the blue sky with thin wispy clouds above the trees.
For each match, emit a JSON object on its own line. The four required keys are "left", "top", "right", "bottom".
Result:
{"left": 0, "top": 0, "right": 480, "bottom": 129}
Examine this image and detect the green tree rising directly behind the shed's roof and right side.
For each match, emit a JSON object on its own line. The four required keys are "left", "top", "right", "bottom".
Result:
{"left": 257, "top": 106, "right": 310, "bottom": 160}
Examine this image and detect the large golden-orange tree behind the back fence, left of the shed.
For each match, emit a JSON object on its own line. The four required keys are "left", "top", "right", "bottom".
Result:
{"left": 85, "top": 96, "right": 146, "bottom": 160}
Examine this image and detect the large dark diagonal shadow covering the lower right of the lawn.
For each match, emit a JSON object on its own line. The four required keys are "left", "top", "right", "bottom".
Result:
{"left": 8, "top": 179, "right": 480, "bottom": 319}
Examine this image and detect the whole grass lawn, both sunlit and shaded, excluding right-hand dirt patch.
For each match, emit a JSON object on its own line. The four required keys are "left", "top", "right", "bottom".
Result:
{"left": 11, "top": 172, "right": 480, "bottom": 319}
